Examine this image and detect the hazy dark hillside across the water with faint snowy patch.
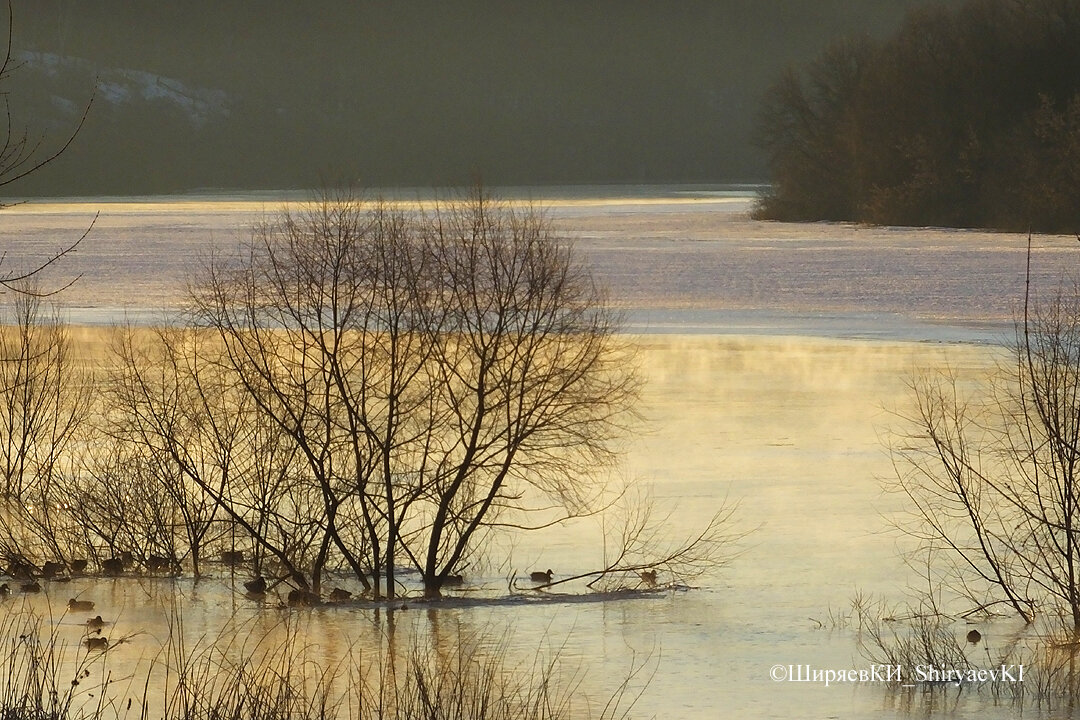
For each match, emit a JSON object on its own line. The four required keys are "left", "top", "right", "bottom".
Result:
{"left": 5, "top": 0, "right": 946, "bottom": 194}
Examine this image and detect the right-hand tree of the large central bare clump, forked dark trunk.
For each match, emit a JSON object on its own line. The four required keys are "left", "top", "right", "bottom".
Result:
{"left": 409, "top": 191, "right": 637, "bottom": 595}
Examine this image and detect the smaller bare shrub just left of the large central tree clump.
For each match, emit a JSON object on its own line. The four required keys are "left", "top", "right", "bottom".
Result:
{"left": 108, "top": 327, "right": 318, "bottom": 578}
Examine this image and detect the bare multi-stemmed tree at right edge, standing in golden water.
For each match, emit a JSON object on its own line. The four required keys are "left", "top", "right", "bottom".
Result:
{"left": 895, "top": 252, "right": 1080, "bottom": 633}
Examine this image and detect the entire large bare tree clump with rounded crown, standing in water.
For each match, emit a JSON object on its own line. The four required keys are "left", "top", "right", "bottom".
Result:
{"left": 185, "top": 192, "right": 636, "bottom": 597}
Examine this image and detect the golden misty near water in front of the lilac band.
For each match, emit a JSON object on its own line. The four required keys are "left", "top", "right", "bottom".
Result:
{"left": 0, "top": 330, "right": 998, "bottom": 718}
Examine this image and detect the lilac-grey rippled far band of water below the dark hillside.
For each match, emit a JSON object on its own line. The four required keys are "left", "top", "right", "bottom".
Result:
{"left": 0, "top": 191, "right": 1062, "bottom": 340}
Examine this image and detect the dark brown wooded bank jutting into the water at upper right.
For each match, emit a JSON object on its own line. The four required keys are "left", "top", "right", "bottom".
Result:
{"left": 758, "top": 0, "right": 1080, "bottom": 233}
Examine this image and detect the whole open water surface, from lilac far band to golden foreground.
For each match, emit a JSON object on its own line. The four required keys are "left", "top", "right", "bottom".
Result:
{"left": 0, "top": 192, "right": 1067, "bottom": 718}
